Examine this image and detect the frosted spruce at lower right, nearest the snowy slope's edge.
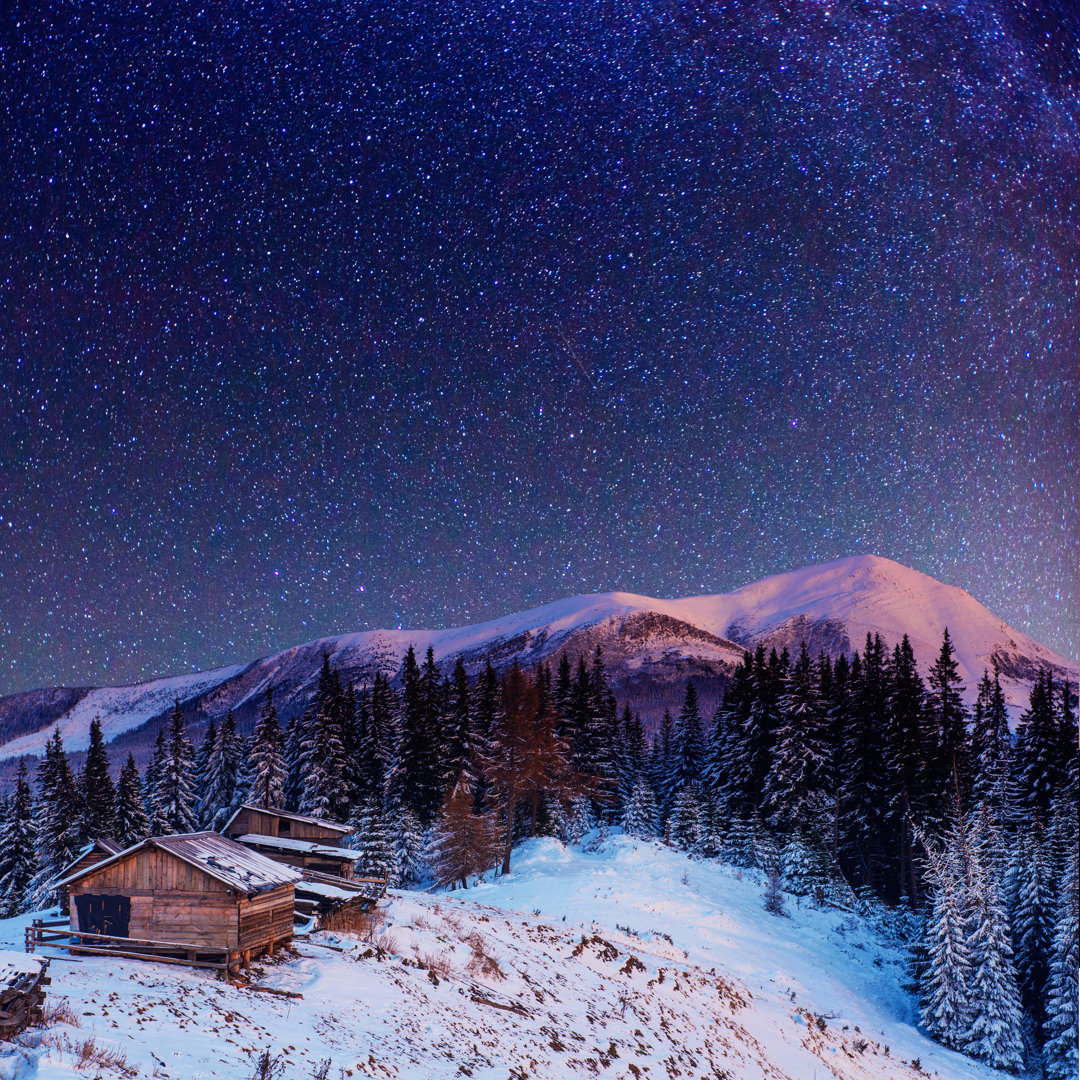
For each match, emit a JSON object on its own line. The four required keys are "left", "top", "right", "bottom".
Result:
{"left": 920, "top": 815, "right": 973, "bottom": 1050}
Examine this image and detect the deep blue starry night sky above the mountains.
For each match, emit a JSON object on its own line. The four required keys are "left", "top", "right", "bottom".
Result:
{"left": 0, "top": 0, "right": 1080, "bottom": 692}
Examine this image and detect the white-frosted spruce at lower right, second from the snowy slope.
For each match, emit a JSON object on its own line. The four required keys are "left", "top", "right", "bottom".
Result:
{"left": 960, "top": 810, "right": 1024, "bottom": 1070}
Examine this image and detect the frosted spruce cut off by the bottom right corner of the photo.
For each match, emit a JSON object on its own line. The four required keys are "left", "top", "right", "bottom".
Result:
{"left": 1042, "top": 846, "right": 1080, "bottom": 1080}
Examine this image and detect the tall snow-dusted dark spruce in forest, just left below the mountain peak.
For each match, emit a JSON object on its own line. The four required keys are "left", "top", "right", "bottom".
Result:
{"left": 762, "top": 640, "right": 829, "bottom": 829}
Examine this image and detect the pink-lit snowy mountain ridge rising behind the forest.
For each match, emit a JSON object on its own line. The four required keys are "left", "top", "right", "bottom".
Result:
{"left": 0, "top": 555, "right": 1078, "bottom": 759}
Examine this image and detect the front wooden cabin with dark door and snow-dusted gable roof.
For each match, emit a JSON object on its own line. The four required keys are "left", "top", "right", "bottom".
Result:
{"left": 59, "top": 833, "right": 300, "bottom": 966}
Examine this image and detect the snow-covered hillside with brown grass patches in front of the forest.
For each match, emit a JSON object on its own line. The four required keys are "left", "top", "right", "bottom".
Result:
{"left": 0, "top": 836, "right": 998, "bottom": 1080}
